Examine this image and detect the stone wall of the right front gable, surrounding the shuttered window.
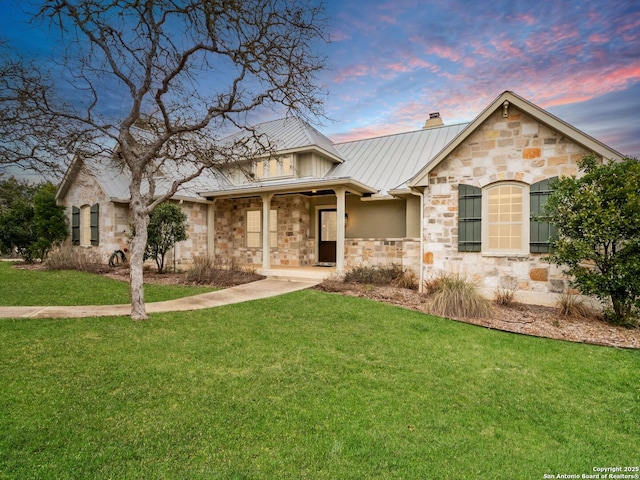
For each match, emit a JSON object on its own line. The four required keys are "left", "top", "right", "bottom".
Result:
{"left": 422, "top": 107, "right": 588, "bottom": 293}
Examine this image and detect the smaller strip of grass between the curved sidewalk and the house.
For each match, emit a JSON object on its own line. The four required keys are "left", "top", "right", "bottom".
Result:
{"left": 0, "top": 262, "right": 215, "bottom": 306}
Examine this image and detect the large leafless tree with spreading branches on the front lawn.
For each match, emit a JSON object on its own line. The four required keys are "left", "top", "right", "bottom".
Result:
{"left": 9, "top": 0, "right": 325, "bottom": 320}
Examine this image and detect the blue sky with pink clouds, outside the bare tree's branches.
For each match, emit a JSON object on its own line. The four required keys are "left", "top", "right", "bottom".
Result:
{"left": 0, "top": 0, "right": 640, "bottom": 158}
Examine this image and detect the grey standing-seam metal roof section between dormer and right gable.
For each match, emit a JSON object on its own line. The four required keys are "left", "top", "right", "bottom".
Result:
{"left": 327, "top": 123, "right": 467, "bottom": 195}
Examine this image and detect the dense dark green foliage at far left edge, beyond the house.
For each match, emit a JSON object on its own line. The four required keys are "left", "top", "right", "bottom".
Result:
{"left": 0, "top": 178, "right": 68, "bottom": 262}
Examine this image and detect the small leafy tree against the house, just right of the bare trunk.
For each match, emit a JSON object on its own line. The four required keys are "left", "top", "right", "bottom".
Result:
{"left": 144, "top": 203, "right": 187, "bottom": 273}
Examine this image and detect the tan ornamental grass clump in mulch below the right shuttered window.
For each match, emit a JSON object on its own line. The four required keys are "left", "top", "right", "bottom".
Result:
{"left": 431, "top": 275, "right": 491, "bottom": 318}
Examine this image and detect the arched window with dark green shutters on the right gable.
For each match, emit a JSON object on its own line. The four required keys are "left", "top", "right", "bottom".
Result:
{"left": 458, "top": 177, "right": 557, "bottom": 254}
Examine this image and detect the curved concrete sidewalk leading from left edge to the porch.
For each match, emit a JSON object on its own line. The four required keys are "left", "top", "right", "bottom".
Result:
{"left": 0, "top": 278, "right": 320, "bottom": 318}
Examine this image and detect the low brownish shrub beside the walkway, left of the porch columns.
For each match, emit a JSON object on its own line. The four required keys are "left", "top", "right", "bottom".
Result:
{"left": 185, "top": 256, "right": 264, "bottom": 287}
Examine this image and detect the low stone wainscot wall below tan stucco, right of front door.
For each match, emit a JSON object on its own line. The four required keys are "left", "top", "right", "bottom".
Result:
{"left": 345, "top": 238, "right": 420, "bottom": 273}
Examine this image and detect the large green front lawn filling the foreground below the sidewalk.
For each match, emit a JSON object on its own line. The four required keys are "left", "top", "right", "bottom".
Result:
{"left": 0, "top": 290, "right": 640, "bottom": 480}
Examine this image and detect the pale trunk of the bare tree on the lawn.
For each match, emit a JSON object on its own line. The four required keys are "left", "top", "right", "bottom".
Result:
{"left": 129, "top": 195, "right": 149, "bottom": 320}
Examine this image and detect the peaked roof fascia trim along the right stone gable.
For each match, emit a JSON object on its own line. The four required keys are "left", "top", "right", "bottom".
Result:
{"left": 408, "top": 91, "right": 623, "bottom": 187}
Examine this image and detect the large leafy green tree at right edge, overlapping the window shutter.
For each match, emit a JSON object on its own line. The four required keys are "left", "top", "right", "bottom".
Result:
{"left": 545, "top": 155, "right": 640, "bottom": 324}
